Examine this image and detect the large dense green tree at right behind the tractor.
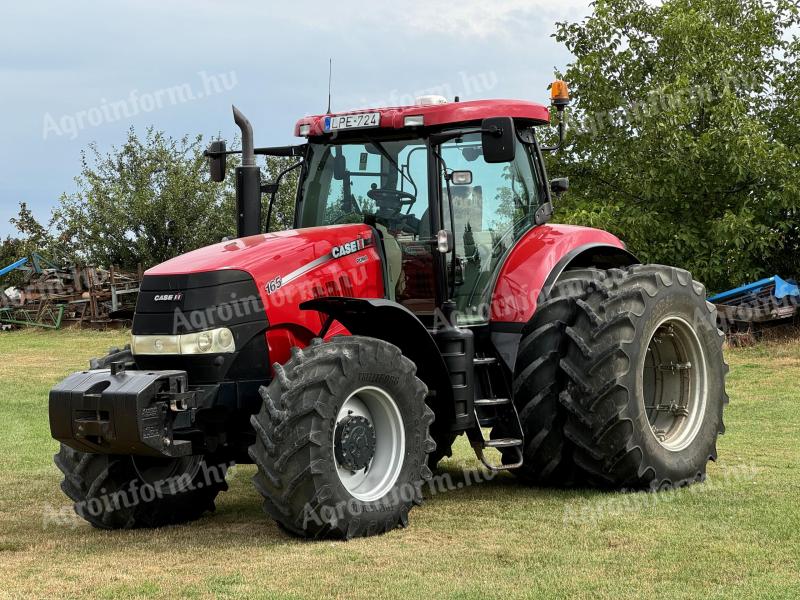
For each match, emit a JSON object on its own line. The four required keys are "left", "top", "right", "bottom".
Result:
{"left": 550, "top": 0, "right": 800, "bottom": 290}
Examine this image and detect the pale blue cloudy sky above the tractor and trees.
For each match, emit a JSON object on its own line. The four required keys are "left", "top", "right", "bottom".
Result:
{"left": 0, "top": 0, "right": 589, "bottom": 237}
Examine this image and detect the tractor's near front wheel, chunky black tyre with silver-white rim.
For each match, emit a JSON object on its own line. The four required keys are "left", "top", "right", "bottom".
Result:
{"left": 250, "top": 336, "right": 435, "bottom": 539}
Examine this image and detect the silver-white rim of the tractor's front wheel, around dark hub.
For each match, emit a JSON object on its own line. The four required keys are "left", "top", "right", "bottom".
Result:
{"left": 333, "top": 386, "right": 406, "bottom": 502}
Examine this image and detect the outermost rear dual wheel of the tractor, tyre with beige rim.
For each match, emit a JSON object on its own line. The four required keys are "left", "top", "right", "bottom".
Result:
{"left": 559, "top": 265, "right": 728, "bottom": 490}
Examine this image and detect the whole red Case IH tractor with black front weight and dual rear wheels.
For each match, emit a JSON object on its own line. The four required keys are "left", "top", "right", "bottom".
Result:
{"left": 50, "top": 82, "right": 727, "bottom": 538}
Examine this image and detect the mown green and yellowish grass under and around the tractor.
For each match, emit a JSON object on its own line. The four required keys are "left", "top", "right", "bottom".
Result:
{"left": 0, "top": 331, "right": 800, "bottom": 598}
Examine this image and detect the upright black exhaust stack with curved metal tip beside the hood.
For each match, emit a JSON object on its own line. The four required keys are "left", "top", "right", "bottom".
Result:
{"left": 233, "top": 106, "right": 261, "bottom": 237}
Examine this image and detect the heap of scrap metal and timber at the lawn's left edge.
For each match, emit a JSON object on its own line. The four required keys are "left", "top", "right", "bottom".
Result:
{"left": 0, "top": 254, "right": 141, "bottom": 329}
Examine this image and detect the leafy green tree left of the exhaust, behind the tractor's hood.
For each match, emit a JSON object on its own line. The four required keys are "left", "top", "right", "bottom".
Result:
{"left": 51, "top": 128, "right": 235, "bottom": 269}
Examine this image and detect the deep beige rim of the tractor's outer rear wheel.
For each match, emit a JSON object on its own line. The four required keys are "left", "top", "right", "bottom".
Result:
{"left": 642, "top": 317, "right": 708, "bottom": 452}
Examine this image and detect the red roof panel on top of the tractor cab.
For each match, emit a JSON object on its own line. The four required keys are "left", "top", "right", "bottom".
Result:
{"left": 294, "top": 100, "right": 550, "bottom": 137}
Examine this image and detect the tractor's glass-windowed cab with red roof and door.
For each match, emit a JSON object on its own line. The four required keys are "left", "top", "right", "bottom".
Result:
{"left": 295, "top": 96, "right": 551, "bottom": 325}
